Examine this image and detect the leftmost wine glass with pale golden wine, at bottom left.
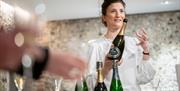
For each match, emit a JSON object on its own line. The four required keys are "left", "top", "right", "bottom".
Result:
{"left": 14, "top": 74, "right": 25, "bottom": 91}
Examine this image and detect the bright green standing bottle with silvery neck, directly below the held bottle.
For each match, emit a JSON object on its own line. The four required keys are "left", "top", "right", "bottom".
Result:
{"left": 110, "top": 60, "right": 123, "bottom": 91}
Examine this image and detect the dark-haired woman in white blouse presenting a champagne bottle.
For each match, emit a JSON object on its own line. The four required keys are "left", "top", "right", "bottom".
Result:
{"left": 88, "top": 0, "right": 155, "bottom": 91}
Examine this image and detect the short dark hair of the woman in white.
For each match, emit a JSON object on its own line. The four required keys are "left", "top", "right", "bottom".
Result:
{"left": 101, "top": 0, "right": 126, "bottom": 26}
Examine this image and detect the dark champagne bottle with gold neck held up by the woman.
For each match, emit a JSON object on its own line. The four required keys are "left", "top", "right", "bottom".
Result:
{"left": 107, "top": 19, "right": 127, "bottom": 60}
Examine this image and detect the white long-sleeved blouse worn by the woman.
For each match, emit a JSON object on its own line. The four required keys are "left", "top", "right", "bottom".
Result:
{"left": 87, "top": 36, "right": 155, "bottom": 91}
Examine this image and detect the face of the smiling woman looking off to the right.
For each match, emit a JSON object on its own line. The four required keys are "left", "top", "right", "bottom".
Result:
{"left": 103, "top": 2, "right": 125, "bottom": 30}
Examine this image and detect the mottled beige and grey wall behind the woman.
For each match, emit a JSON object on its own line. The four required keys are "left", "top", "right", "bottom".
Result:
{"left": 1, "top": 11, "right": 180, "bottom": 91}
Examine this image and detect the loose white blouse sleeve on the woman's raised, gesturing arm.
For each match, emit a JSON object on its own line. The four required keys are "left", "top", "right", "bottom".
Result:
{"left": 136, "top": 37, "right": 156, "bottom": 84}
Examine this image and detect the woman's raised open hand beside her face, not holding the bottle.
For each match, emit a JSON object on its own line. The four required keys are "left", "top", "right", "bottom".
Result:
{"left": 135, "top": 28, "right": 149, "bottom": 53}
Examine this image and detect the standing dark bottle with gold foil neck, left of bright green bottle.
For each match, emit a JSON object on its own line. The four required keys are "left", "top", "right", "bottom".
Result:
{"left": 94, "top": 62, "right": 107, "bottom": 91}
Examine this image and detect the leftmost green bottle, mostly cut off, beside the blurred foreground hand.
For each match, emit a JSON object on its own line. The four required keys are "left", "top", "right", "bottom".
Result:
{"left": 75, "top": 77, "right": 88, "bottom": 91}
